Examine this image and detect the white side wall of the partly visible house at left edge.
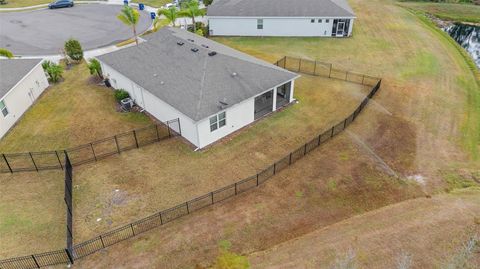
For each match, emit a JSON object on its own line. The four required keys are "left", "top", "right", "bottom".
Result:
{"left": 0, "top": 63, "right": 48, "bottom": 138}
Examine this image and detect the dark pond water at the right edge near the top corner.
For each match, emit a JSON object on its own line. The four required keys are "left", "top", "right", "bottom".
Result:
{"left": 444, "top": 23, "right": 480, "bottom": 68}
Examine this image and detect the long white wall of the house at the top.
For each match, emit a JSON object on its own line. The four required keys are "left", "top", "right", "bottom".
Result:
{"left": 208, "top": 17, "right": 354, "bottom": 37}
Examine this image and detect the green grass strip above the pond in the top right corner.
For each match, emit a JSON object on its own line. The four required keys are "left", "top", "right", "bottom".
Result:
{"left": 400, "top": 2, "right": 480, "bottom": 23}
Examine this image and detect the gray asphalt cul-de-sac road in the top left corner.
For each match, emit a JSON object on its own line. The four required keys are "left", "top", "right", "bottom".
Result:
{"left": 0, "top": 4, "right": 151, "bottom": 56}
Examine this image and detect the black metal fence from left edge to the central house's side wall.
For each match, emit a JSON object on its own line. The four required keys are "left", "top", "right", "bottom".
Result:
{"left": 0, "top": 119, "right": 181, "bottom": 173}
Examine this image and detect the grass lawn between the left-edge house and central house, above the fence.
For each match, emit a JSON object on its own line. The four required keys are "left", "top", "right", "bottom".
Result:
{"left": 0, "top": 63, "right": 152, "bottom": 153}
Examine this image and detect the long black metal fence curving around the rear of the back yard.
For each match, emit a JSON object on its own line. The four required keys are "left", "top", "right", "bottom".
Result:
{"left": 0, "top": 56, "right": 382, "bottom": 269}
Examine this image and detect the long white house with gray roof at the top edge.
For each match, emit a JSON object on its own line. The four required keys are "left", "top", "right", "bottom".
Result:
{"left": 207, "top": 0, "right": 355, "bottom": 37}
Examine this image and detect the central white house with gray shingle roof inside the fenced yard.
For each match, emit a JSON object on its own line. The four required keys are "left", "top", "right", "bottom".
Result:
{"left": 97, "top": 27, "right": 298, "bottom": 148}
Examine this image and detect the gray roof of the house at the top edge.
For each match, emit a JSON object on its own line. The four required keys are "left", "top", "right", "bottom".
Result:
{"left": 207, "top": 0, "right": 355, "bottom": 17}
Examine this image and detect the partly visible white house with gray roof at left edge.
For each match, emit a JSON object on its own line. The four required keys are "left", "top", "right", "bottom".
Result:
{"left": 0, "top": 59, "right": 48, "bottom": 138}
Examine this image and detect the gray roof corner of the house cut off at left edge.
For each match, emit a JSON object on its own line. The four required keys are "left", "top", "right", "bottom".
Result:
{"left": 0, "top": 59, "right": 42, "bottom": 99}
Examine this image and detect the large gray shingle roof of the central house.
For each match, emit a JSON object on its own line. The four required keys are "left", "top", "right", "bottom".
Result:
{"left": 97, "top": 27, "right": 298, "bottom": 121}
